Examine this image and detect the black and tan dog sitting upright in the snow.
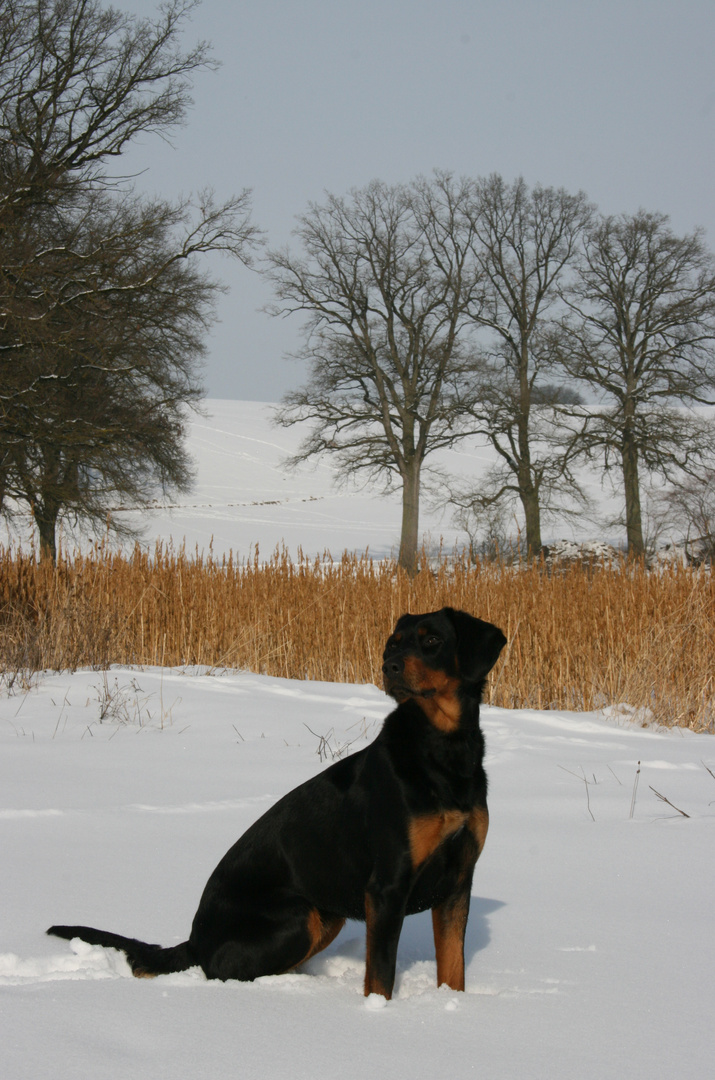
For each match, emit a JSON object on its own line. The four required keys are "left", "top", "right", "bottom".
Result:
{"left": 48, "top": 608, "right": 505, "bottom": 998}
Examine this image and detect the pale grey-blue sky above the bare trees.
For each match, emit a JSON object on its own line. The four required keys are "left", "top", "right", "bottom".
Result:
{"left": 120, "top": 0, "right": 715, "bottom": 401}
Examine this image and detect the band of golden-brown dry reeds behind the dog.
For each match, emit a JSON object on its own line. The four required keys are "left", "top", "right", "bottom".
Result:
{"left": 0, "top": 546, "right": 715, "bottom": 730}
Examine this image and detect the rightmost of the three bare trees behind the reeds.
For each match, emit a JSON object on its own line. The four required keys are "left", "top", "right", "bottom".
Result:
{"left": 558, "top": 211, "right": 715, "bottom": 556}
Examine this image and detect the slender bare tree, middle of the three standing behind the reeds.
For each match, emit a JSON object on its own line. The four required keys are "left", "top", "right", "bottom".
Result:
{"left": 460, "top": 175, "right": 593, "bottom": 554}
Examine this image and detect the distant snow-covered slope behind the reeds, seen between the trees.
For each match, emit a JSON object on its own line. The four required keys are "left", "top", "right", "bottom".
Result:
{"left": 0, "top": 400, "right": 622, "bottom": 557}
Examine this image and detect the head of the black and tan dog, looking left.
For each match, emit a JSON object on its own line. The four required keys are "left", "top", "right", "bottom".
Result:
{"left": 382, "top": 607, "right": 507, "bottom": 730}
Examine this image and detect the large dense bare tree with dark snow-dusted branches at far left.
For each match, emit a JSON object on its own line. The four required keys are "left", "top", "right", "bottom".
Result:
{"left": 0, "top": 0, "right": 256, "bottom": 557}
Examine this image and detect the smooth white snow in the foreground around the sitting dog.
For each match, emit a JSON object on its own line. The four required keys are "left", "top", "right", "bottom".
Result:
{"left": 0, "top": 669, "right": 715, "bottom": 1080}
